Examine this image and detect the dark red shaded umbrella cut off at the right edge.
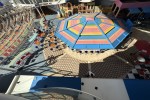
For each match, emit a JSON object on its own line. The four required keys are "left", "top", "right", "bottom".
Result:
{"left": 135, "top": 40, "right": 150, "bottom": 55}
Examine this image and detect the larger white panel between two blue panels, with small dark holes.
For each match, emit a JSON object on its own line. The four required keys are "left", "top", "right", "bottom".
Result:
{"left": 81, "top": 78, "right": 129, "bottom": 100}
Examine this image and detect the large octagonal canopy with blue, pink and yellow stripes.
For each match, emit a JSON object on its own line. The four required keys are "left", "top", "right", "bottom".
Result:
{"left": 55, "top": 13, "right": 128, "bottom": 50}
